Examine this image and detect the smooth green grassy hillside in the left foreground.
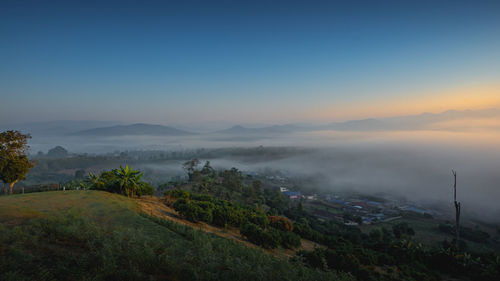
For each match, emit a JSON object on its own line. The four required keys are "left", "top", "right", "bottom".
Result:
{"left": 0, "top": 191, "right": 351, "bottom": 280}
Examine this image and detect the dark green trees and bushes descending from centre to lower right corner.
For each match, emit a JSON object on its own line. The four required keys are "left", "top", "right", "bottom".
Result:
{"left": 167, "top": 160, "right": 500, "bottom": 280}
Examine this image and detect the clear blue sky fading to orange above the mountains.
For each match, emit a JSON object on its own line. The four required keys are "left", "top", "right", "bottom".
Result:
{"left": 0, "top": 0, "right": 500, "bottom": 125}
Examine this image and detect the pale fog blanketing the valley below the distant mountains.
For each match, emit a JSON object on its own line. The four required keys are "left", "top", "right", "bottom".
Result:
{"left": 25, "top": 126, "right": 500, "bottom": 221}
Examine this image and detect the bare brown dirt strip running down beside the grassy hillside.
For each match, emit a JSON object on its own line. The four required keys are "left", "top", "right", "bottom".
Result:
{"left": 137, "top": 196, "right": 324, "bottom": 258}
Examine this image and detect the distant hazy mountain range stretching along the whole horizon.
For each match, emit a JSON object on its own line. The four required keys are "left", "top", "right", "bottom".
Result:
{"left": 1, "top": 109, "right": 500, "bottom": 136}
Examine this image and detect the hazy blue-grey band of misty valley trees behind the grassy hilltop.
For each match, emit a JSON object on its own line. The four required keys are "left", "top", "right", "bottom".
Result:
{"left": 22, "top": 147, "right": 310, "bottom": 187}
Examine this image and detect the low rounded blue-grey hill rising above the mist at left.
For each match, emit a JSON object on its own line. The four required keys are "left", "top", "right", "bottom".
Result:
{"left": 71, "top": 123, "right": 194, "bottom": 137}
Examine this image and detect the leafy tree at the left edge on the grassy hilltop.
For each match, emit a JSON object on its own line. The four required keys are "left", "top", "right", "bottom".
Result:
{"left": 0, "top": 131, "right": 33, "bottom": 194}
